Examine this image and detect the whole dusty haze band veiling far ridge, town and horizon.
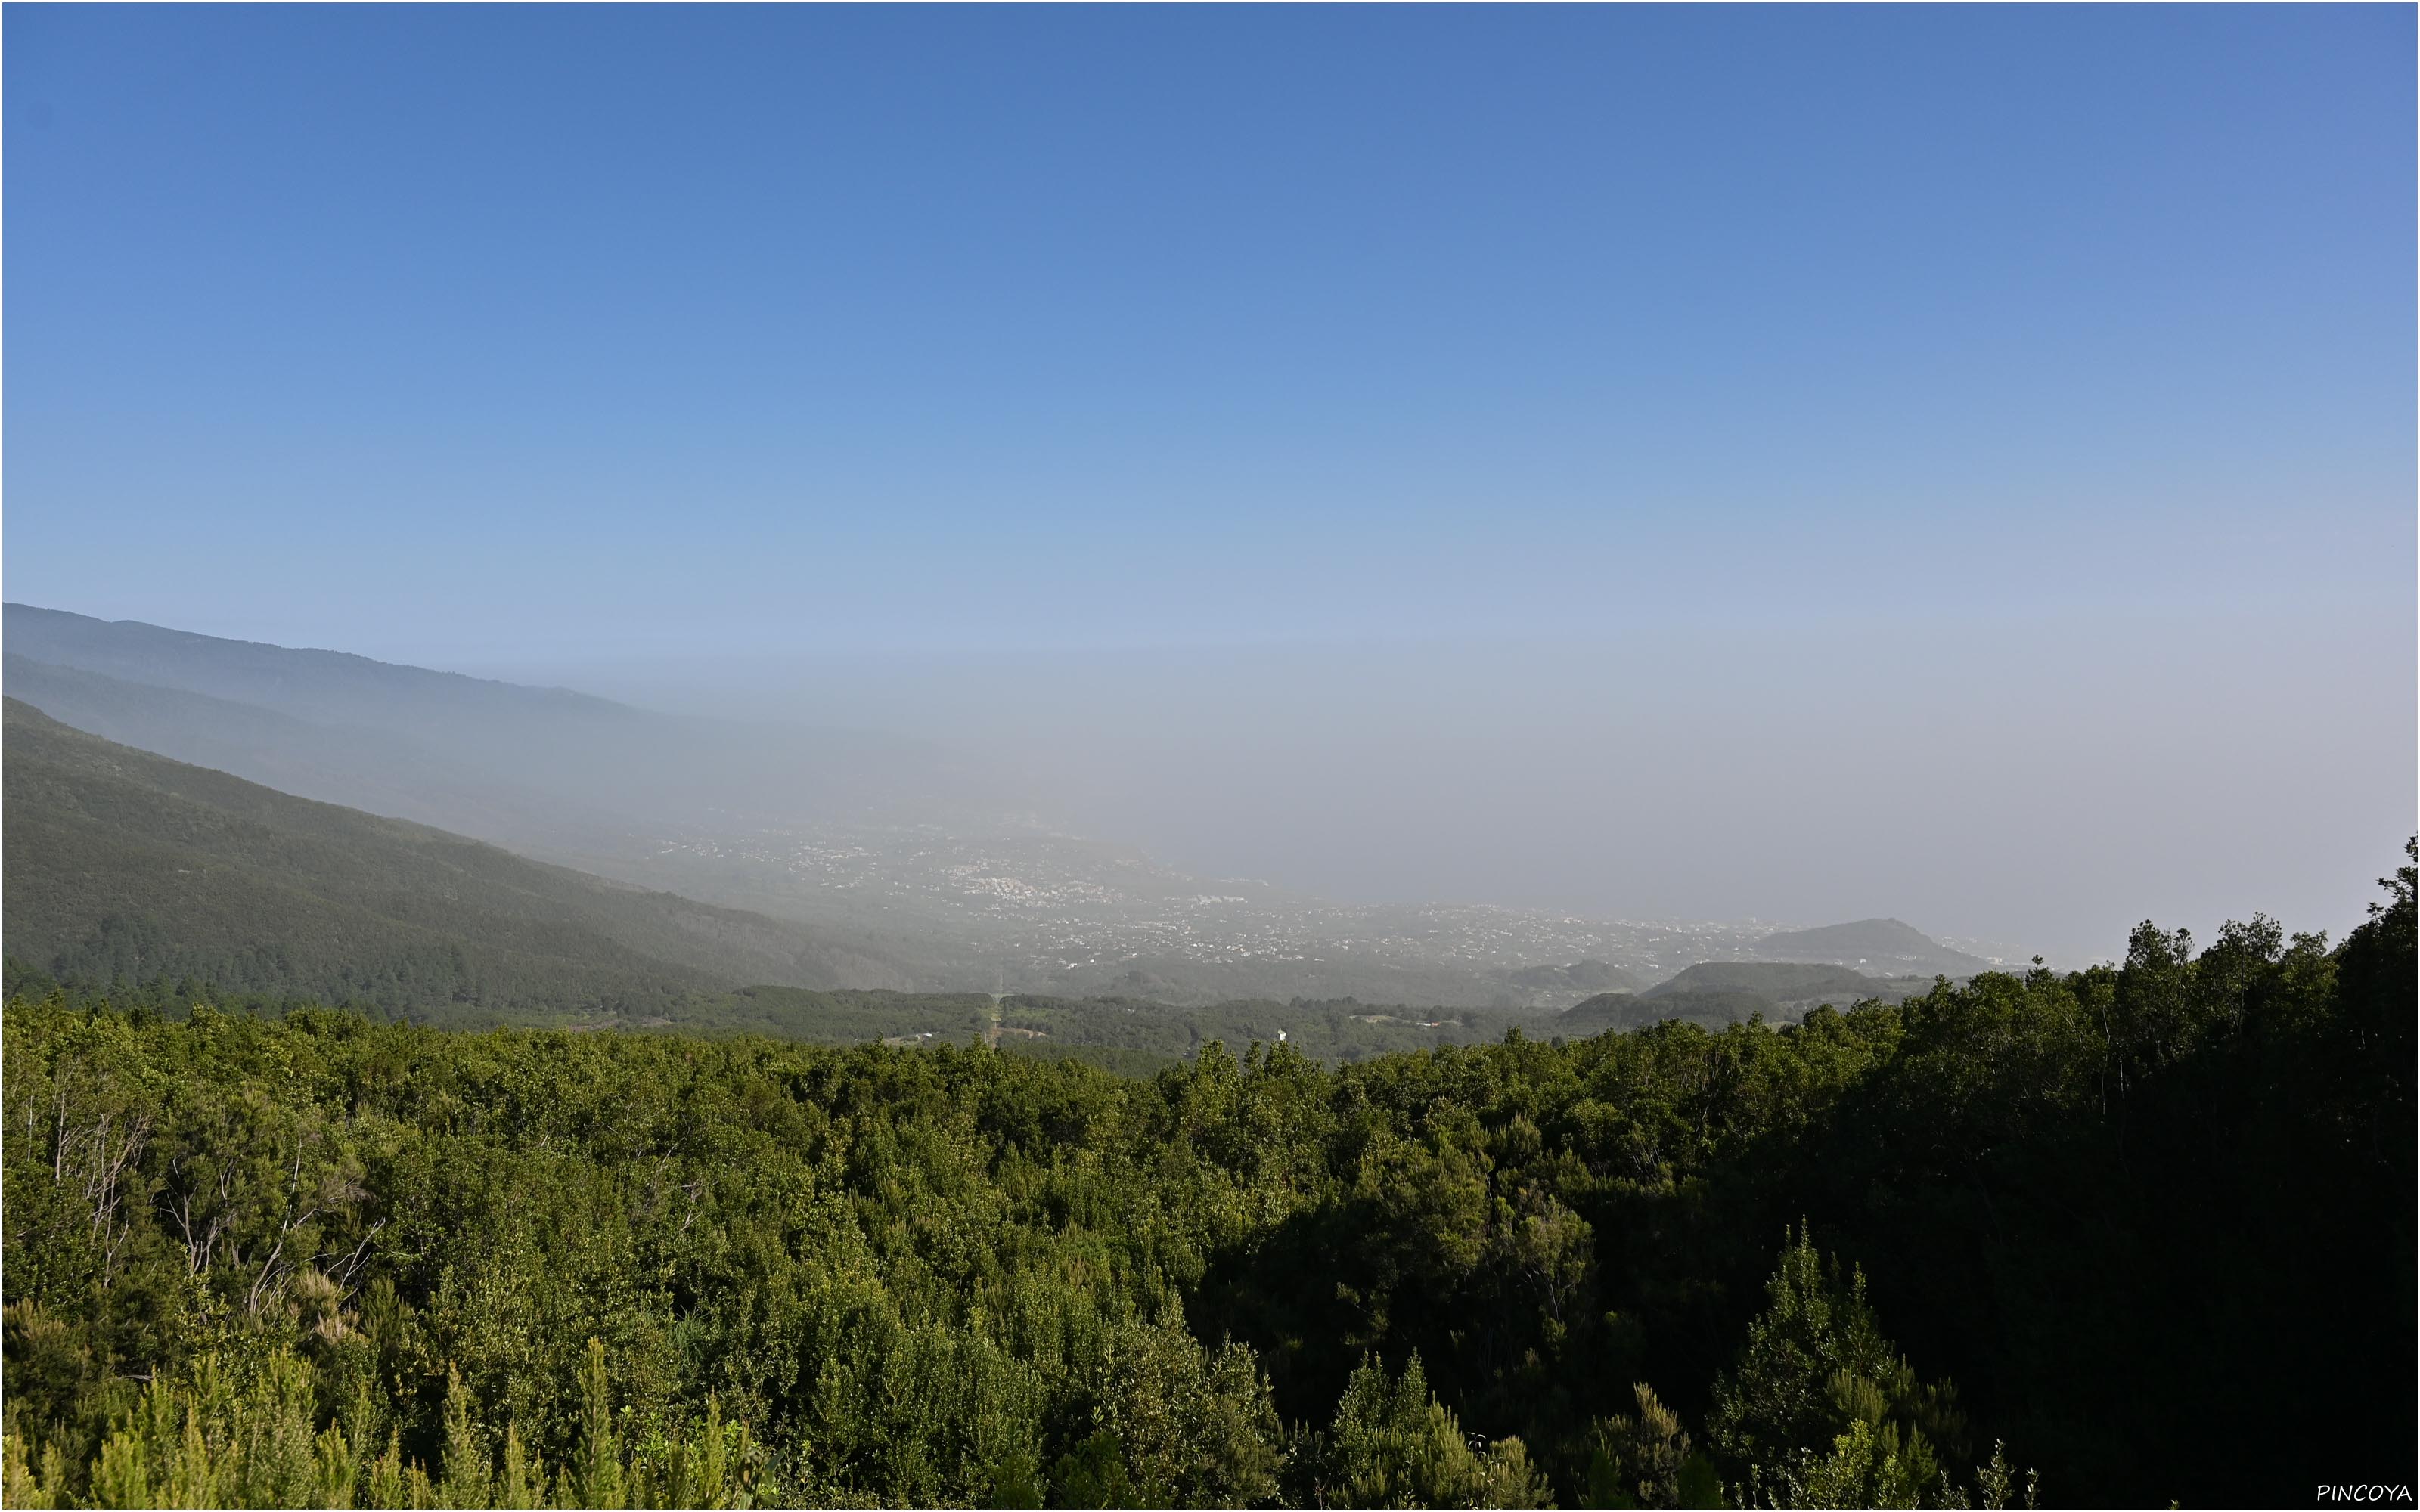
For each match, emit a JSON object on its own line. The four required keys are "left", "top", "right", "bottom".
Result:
{"left": 8, "top": 605, "right": 2391, "bottom": 1009}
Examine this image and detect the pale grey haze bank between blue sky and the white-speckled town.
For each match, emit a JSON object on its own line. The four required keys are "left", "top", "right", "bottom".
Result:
{"left": 482, "top": 602, "right": 2412, "bottom": 965}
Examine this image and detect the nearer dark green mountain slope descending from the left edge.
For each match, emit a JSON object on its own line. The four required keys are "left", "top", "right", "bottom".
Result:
{"left": 0, "top": 699, "right": 908, "bottom": 1016}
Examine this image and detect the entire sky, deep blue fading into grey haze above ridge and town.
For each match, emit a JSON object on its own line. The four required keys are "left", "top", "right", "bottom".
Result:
{"left": 5, "top": 8, "right": 2420, "bottom": 943}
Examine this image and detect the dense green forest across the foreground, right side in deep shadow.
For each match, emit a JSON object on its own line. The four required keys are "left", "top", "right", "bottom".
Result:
{"left": 5, "top": 841, "right": 2415, "bottom": 1507}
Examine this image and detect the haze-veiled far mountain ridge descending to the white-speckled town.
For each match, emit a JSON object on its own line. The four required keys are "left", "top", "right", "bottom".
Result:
{"left": 8, "top": 605, "right": 1987, "bottom": 1009}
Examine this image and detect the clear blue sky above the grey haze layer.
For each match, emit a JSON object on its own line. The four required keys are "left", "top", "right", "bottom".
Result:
{"left": 5, "top": 8, "right": 2415, "bottom": 653}
